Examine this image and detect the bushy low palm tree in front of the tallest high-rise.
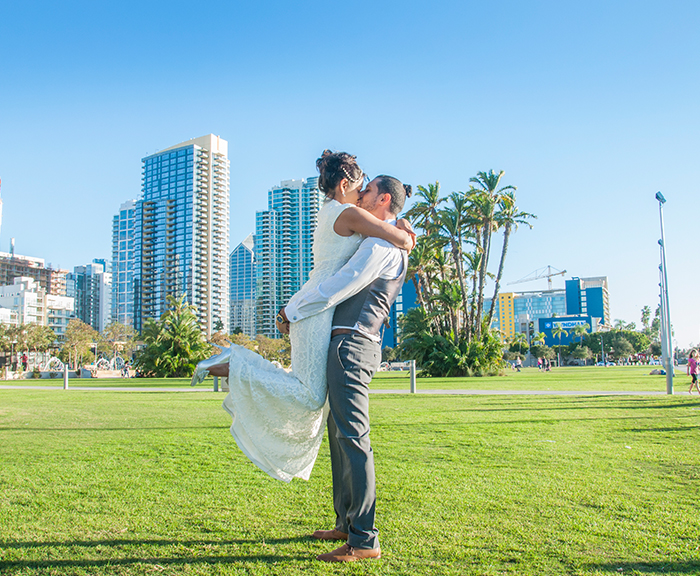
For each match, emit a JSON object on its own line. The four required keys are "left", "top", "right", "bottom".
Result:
{"left": 136, "top": 294, "right": 211, "bottom": 378}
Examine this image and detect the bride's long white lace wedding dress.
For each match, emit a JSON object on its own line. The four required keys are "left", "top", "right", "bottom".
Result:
{"left": 223, "top": 200, "right": 363, "bottom": 482}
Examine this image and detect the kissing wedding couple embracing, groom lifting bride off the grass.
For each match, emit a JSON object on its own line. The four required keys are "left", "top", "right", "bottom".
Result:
{"left": 192, "top": 150, "right": 416, "bottom": 562}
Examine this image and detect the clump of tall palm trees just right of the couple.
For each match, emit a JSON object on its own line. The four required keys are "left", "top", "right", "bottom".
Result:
{"left": 402, "top": 170, "right": 532, "bottom": 374}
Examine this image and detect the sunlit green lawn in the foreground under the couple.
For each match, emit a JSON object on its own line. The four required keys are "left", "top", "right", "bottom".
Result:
{"left": 0, "top": 384, "right": 700, "bottom": 576}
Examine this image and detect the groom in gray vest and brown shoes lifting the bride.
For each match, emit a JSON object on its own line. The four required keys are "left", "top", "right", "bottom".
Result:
{"left": 277, "top": 176, "right": 411, "bottom": 562}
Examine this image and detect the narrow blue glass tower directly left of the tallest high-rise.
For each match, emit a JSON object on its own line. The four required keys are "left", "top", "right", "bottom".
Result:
{"left": 112, "top": 200, "right": 136, "bottom": 326}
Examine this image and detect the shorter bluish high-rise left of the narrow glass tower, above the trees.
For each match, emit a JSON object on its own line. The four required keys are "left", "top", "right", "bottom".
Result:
{"left": 66, "top": 259, "right": 112, "bottom": 332}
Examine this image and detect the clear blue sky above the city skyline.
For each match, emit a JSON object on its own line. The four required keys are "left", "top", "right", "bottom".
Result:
{"left": 0, "top": 0, "right": 700, "bottom": 346}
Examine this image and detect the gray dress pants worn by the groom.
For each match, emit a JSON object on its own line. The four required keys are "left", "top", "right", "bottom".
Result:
{"left": 327, "top": 334, "right": 382, "bottom": 548}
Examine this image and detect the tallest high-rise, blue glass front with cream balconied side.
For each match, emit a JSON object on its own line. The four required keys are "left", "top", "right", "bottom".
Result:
{"left": 132, "top": 134, "right": 229, "bottom": 335}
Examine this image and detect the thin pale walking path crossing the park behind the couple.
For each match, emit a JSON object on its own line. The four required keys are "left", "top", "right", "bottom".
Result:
{"left": 0, "top": 384, "right": 688, "bottom": 396}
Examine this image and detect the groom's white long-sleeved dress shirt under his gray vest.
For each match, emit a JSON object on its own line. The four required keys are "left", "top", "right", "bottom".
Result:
{"left": 285, "top": 230, "right": 404, "bottom": 341}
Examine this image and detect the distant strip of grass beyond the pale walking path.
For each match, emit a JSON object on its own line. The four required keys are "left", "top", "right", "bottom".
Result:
{"left": 0, "top": 366, "right": 690, "bottom": 392}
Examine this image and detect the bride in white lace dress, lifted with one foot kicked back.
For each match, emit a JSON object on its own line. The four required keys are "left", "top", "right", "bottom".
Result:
{"left": 192, "top": 150, "right": 415, "bottom": 482}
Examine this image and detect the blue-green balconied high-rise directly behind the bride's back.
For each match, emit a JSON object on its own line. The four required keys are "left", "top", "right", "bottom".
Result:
{"left": 254, "top": 177, "right": 324, "bottom": 338}
